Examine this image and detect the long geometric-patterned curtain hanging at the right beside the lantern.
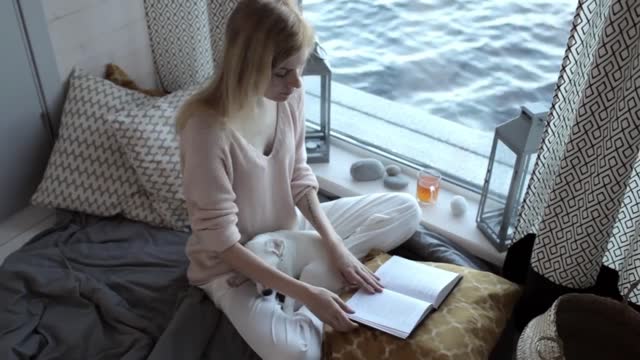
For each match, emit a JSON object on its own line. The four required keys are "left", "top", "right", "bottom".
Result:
{"left": 515, "top": 0, "right": 640, "bottom": 303}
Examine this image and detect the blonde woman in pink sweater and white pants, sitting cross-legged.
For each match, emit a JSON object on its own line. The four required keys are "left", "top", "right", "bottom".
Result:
{"left": 177, "top": 0, "right": 420, "bottom": 359}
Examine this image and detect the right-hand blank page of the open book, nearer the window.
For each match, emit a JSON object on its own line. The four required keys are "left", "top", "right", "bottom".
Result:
{"left": 376, "top": 256, "right": 460, "bottom": 307}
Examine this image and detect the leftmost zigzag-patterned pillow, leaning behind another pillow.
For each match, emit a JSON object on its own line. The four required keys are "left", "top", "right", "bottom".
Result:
{"left": 31, "top": 69, "right": 155, "bottom": 216}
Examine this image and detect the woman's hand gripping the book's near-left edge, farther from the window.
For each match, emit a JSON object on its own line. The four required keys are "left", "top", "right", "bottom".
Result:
{"left": 300, "top": 285, "right": 358, "bottom": 331}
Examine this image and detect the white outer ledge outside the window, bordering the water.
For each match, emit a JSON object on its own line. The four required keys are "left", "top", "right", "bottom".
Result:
{"left": 304, "top": 76, "right": 517, "bottom": 193}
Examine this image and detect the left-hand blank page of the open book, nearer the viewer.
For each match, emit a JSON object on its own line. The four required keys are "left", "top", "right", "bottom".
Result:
{"left": 347, "top": 289, "right": 431, "bottom": 338}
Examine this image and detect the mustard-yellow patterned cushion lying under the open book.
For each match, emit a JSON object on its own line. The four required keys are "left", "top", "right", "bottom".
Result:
{"left": 323, "top": 254, "right": 521, "bottom": 360}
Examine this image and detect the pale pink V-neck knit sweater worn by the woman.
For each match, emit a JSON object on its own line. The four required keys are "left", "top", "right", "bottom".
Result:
{"left": 180, "top": 90, "right": 318, "bottom": 285}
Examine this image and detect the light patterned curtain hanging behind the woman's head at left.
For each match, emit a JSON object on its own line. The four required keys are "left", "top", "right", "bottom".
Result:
{"left": 144, "top": 0, "right": 239, "bottom": 92}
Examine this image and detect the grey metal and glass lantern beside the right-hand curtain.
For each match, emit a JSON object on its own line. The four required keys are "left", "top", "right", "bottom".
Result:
{"left": 476, "top": 106, "right": 546, "bottom": 251}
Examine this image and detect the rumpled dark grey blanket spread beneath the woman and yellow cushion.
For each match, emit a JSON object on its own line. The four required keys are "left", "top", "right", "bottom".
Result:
{"left": 0, "top": 212, "right": 485, "bottom": 360}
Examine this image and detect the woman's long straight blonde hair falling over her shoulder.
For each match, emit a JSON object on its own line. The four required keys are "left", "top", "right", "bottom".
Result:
{"left": 176, "top": 0, "right": 315, "bottom": 131}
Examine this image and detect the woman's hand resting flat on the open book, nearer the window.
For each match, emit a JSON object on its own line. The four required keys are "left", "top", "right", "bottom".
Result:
{"left": 330, "top": 243, "right": 382, "bottom": 293}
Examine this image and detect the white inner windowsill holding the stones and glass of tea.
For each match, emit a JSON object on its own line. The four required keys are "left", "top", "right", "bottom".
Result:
{"left": 311, "top": 139, "right": 505, "bottom": 267}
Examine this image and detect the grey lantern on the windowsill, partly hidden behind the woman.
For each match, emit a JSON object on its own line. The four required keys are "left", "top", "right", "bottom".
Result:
{"left": 302, "top": 42, "right": 331, "bottom": 163}
